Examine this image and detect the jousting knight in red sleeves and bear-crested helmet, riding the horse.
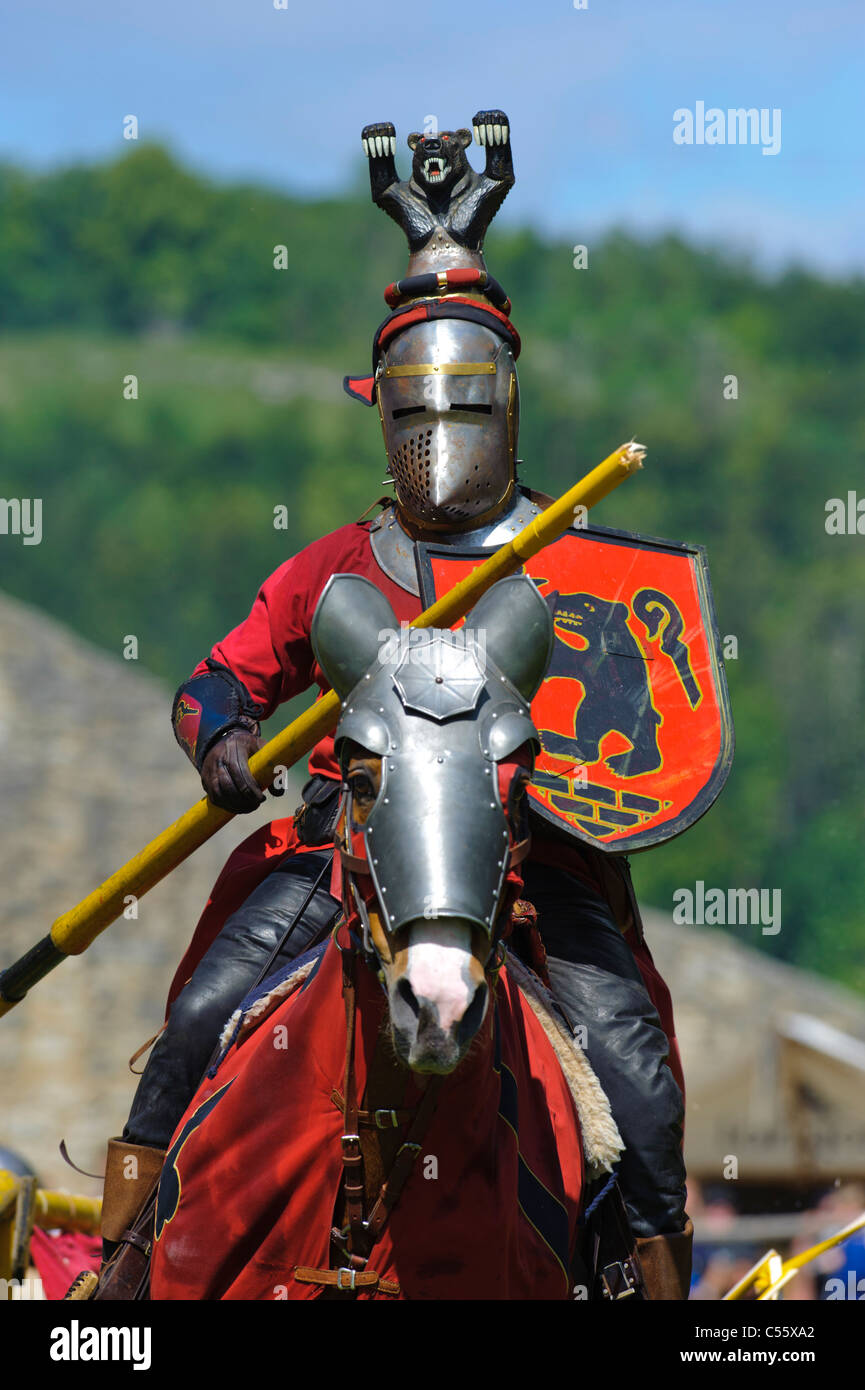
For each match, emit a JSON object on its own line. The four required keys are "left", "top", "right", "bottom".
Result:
{"left": 103, "top": 110, "right": 691, "bottom": 1300}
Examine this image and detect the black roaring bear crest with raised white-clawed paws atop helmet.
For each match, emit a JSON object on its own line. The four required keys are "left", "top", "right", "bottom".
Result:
{"left": 360, "top": 110, "right": 515, "bottom": 275}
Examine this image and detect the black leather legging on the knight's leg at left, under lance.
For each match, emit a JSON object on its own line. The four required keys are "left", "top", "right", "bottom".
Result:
{"left": 124, "top": 852, "right": 339, "bottom": 1148}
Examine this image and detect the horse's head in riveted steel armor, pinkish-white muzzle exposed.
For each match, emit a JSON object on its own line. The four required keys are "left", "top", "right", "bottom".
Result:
{"left": 312, "top": 574, "right": 552, "bottom": 1072}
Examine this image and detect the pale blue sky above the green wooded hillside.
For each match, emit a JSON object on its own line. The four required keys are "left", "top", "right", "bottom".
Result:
{"left": 0, "top": 0, "right": 865, "bottom": 274}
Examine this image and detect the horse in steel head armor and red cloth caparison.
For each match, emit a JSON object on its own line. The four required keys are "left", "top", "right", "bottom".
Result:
{"left": 150, "top": 575, "right": 622, "bottom": 1300}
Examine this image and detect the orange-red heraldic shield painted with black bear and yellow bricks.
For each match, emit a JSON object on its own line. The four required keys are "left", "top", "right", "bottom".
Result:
{"left": 417, "top": 527, "right": 733, "bottom": 853}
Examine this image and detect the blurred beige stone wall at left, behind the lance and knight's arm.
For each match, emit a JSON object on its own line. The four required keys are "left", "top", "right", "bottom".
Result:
{"left": 0, "top": 596, "right": 304, "bottom": 1194}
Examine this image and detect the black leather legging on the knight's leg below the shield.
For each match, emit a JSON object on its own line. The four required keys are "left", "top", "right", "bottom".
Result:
{"left": 517, "top": 865, "right": 686, "bottom": 1236}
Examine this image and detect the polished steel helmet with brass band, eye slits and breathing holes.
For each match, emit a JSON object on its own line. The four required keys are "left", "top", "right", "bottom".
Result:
{"left": 375, "top": 318, "right": 520, "bottom": 531}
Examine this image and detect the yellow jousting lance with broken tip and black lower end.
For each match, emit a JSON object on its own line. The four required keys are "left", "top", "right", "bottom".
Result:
{"left": 0, "top": 441, "right": 645, "bottom": 1017}
